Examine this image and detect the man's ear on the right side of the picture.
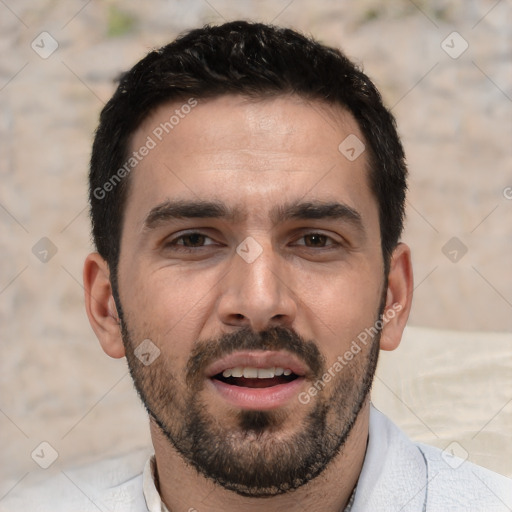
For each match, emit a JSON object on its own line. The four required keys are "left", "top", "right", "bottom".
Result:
{"left": 380, "top": 243, "right": 413, "bottom": 350}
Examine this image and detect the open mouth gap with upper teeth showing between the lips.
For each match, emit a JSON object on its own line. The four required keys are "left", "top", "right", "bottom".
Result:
{"left": 213, "top": 366, "right": 299, "bottom": 388}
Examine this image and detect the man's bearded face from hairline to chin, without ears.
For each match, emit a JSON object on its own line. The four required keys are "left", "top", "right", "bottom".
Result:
{"left": 118, "top": 96, "right": 385, "bottom": 496}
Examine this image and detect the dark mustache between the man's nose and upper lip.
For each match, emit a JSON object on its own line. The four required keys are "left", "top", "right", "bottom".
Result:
{"left": 186, "top": 326, "right": 325, "bottom": 388}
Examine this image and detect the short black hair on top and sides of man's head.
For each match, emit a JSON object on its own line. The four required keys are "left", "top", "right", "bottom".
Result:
{"left": 89, "top": 21, "right": 407, "bottom": 293}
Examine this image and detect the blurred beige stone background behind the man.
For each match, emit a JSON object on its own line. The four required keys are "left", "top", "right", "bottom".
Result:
{"left": 0, "top": 0, "right": 512, "bottom": 500}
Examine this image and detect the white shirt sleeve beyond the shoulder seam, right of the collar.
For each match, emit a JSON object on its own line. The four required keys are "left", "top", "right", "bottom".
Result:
{"left": 416, "top": 443, "right": 512, "bottom": 512}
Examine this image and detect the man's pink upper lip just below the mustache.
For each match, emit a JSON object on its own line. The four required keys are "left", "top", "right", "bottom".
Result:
{"left": 206, "top": 350, "right": 308, "bottom": 377}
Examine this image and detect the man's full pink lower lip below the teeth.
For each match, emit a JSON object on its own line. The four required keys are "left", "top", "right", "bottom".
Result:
{"left": 209, "top": 377, "right": 304, "bottom": 411}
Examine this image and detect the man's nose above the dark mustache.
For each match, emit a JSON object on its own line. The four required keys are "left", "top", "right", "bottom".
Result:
{"left": 217, "top": 244, "right": 297, "bottom": 332}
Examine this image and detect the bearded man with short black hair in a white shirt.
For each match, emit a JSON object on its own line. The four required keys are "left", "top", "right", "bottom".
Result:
{"left": 5, "top": 22, "right": 512, "bottom": 512}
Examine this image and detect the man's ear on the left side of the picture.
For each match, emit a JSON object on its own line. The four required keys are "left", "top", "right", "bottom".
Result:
{"left": 83, "top": 252, "right": 125, "bottom": 358}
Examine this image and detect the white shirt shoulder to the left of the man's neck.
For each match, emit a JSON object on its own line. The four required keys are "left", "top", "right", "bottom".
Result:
{"left": 0, "top": 449, "right": 150, "bottom": 512}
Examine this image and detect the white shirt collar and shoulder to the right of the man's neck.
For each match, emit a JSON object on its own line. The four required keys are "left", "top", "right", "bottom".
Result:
{"left": 352, "top": 406, "right": 512, "bottom": 512}
